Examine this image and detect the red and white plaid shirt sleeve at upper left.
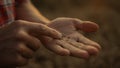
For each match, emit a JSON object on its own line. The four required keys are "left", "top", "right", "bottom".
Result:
{"left": 0, "top": 0, "right": 15, "bottom": 26}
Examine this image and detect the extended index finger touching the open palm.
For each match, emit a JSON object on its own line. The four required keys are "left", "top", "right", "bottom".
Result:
{"left": 16, "top": 20, "right": 62, "bottom": 38}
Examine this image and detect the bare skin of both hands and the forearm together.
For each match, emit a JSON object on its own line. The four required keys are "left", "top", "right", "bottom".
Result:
{"left": 0, "top": 0, "right": 101, "bottom": 68}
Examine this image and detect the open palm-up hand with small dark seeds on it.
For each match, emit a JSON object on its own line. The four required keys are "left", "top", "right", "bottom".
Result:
{"left": 41, "top": 18, "right": 101, "bottom": 59}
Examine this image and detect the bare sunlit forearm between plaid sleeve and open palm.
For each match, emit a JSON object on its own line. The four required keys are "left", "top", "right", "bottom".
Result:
{"left": 16, "top": 0, "right": 50, "bottom": 24}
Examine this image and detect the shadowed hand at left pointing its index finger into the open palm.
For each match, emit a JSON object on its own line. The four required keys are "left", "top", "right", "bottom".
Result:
{"left": 0, "top": 20, "right": 61, "bottom": 68}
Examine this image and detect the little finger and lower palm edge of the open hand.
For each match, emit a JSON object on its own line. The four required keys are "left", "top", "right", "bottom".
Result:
{"left": 41, "top": 36, "right": 70, "bottom": 56}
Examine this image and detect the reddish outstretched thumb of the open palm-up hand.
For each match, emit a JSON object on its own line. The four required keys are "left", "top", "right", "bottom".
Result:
{"left": 74, "top": 19, "right": 99, "bottom": 32}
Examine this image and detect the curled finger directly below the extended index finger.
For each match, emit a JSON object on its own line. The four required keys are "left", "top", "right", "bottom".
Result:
{"left": 14, "top": 31, "right": 41, "bottom": 51}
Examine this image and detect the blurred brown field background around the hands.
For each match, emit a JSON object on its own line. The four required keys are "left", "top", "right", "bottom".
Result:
{"left": 22, "top": 0, "right": 120, "bottom": 68}
